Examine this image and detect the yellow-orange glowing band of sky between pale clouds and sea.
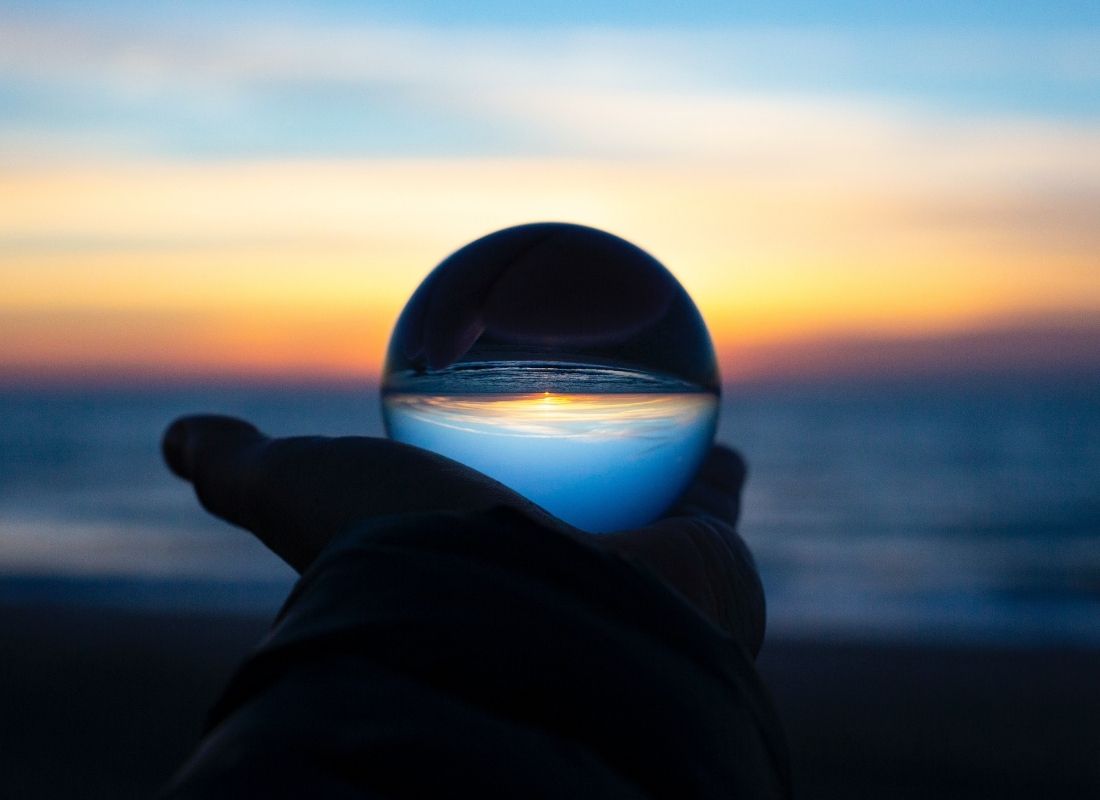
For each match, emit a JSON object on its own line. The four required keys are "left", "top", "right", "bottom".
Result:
{"left": 0, "top": 158, "right": 1100, "bottom": 385}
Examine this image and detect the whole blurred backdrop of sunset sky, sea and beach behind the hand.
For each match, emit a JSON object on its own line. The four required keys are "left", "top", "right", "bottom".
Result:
{"left": 0, "top": 0, "right": 1100, "bottom": 797}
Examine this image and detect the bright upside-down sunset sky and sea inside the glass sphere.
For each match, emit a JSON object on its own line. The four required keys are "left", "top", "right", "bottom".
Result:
{"left": 383, "top": 363, "right": 718, "bottom": 533}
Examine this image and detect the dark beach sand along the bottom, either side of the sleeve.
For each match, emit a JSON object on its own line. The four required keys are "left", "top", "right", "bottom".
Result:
{"left": 0, "top": 605, "right": 1100, "bottom": 799}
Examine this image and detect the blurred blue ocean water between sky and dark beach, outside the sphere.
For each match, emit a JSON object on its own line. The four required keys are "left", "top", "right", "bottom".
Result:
{"left": 0, "top": 379, "right": 1100, "bottom": 647}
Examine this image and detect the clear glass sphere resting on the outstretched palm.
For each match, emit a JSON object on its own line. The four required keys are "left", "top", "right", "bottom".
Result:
{"left": 382, "top": 222, "right": 719, "bottom": 533}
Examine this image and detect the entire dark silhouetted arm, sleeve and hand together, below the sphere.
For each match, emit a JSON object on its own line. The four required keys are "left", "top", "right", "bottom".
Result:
{"left": 157, "top": 417, "right": 789, "bottom": 798}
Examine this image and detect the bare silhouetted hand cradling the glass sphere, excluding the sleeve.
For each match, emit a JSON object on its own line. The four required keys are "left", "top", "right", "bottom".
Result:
{"left": 163, "top": 416, "right": 765, "bottom": 654}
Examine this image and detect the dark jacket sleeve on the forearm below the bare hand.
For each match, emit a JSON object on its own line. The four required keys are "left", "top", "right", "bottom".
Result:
{"left": 165, "top": 508, "right": 790, "bottom": 800}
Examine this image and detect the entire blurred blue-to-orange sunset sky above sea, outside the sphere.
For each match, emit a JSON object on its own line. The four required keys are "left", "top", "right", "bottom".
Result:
{"left": 0, "top": 0, "right": 1100, "bottom": 377}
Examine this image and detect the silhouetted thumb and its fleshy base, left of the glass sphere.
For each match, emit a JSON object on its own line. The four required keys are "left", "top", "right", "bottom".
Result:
{"left": 163, "top": 416, "right": 548, "bottom": 572}
